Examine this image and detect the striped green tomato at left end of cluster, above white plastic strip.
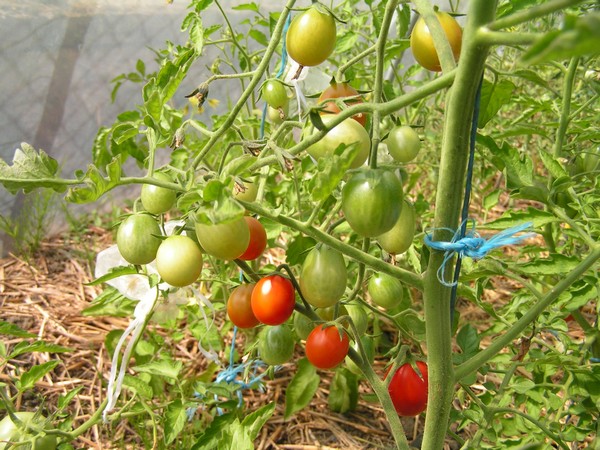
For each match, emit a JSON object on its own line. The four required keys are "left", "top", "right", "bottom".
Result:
{"left": 117, "top": 213, "right": 162, "bottom": 264}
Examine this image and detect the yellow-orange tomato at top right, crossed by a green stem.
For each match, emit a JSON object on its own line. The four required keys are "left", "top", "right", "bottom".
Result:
{"left": 410, "top": 11, "right": 462, "bottom": 72}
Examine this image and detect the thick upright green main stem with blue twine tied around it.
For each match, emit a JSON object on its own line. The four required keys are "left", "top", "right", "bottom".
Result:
{"left": 422, "top": 0, "right": 496, "bottom": 450}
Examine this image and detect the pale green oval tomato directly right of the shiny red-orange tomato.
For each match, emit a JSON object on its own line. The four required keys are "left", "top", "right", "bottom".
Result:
{"left": 300, "top": 244, "right": 348, "bottom": 308}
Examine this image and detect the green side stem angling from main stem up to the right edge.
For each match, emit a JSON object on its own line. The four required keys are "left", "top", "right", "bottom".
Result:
{"left": 454, "top": 246, "right": 600, "bottom": 380}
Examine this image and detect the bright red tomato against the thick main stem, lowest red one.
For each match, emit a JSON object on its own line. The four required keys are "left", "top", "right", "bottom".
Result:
{"left": 388, "top": 361, "right": 428, "bottom": 416}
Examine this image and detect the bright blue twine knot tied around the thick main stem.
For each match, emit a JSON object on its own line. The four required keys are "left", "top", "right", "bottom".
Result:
{"left": 424, "top": 219, "right": 535, "bottom": 287}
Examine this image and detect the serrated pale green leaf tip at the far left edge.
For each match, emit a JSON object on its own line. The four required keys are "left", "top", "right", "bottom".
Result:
{"left": 0, "top": 143, "right": 68, "bottom": 194}
